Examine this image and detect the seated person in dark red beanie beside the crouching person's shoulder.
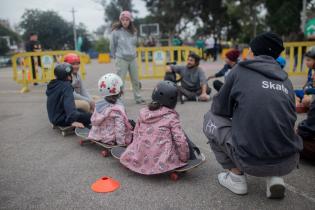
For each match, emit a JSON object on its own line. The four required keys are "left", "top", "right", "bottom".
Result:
{"left": 208, "top": 49, "right": 240, "bottom": 92}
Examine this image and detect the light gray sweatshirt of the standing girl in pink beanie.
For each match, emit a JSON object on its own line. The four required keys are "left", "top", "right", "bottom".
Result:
{"left": 110, "top": 28, "right": 137, "bottom": 61}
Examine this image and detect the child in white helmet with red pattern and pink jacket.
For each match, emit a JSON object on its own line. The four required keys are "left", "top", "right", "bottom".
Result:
{"left": 89, "top": 73, "right": 132, "bottom": 145}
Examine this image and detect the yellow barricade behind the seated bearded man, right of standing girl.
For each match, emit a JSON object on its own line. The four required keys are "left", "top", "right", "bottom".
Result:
{"left": 137, "top": 46, "right": 202, "bottom": 79}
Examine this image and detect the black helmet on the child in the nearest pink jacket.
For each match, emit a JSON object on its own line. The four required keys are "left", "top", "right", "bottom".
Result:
{"left": 152, "top": 81, "right": 177, "bottom": 109}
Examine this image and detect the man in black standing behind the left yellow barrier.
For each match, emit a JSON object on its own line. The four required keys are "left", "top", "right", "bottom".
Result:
{"left": 25, "top": 33, "right": 42, "bottom": 85}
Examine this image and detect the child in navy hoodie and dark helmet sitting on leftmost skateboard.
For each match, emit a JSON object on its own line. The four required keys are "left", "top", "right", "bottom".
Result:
{"left": 46, "top": 63, "right": 91, "bottom": 128}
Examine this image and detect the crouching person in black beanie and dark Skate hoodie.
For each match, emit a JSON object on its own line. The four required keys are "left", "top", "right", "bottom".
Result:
{"left": 203, "top": 32, "right": 303, "bottom": 198}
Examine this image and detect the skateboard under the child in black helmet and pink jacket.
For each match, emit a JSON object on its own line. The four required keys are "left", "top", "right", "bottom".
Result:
{"left": 111, "top": 147, "right": 206, "bottom": 181}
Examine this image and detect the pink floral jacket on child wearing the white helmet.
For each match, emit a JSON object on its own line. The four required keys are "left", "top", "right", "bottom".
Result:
{"left": 88, "top": 100, "right": 132, "bottom": 145}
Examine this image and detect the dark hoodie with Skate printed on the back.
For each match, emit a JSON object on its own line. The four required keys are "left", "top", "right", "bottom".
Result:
{"left": 211, "top": 55, "right": 302, "bottom": 166}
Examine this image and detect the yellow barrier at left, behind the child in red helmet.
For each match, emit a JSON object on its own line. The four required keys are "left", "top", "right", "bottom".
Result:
{"left": 11, "top": 50, "right": 89, "bottom": 93}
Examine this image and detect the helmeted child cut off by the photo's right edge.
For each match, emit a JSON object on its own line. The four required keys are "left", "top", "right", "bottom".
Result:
{"left": 295, "top": 47, "right": 315, "bottom": 109}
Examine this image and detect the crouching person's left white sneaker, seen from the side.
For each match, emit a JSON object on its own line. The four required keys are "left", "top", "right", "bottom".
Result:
{"left": 218, "top": 171, "right": 247, "bottom": 195}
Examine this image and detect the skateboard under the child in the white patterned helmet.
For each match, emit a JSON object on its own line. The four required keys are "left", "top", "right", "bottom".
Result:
{"left": 75, "top": 128, "right": 127, "bottom": 157}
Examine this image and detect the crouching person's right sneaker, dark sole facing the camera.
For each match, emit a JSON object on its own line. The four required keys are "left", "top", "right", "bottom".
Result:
{"left": 266, "top": 176, "right": 285, "bottom": 198}
